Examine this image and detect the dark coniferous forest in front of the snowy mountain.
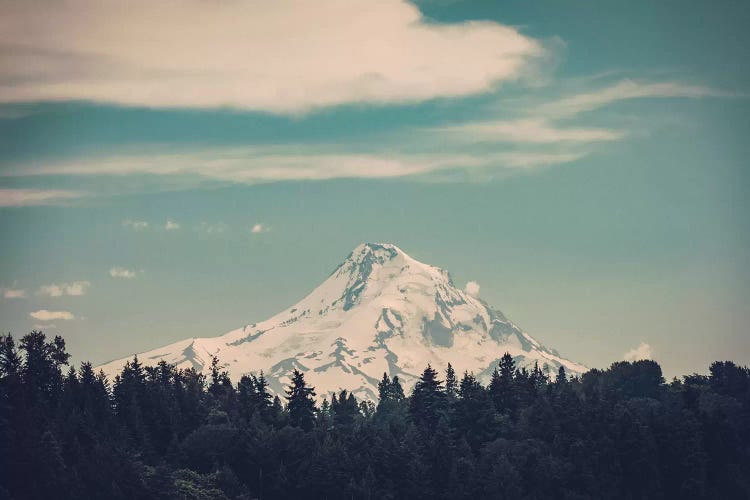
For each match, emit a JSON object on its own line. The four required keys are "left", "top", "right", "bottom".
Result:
{"left": 0, "top": 331, "right": 750, "bottom": 500}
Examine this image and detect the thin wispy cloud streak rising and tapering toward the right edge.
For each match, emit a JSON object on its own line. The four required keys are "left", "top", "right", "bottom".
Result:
{"left": 536, "top": 80, "right": 735, "bottom": 118}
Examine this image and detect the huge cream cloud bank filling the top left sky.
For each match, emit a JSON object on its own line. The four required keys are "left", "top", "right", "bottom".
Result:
{"left": 0, "top": 0, "right": 544, "bottom": 113}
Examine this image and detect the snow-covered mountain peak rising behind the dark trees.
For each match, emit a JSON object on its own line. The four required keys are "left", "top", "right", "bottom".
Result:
{"left": 95, "top": 243, "right": 586, "bottom": 400}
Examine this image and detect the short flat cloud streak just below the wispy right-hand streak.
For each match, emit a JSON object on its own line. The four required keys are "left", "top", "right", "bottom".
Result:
{"left": 428, "top": 118, "right": 624, "bottom": 144}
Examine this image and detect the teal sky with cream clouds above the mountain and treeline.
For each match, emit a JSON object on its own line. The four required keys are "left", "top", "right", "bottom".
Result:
{"left": 0, "top": 0, "right": 750, "bottom": 377}
